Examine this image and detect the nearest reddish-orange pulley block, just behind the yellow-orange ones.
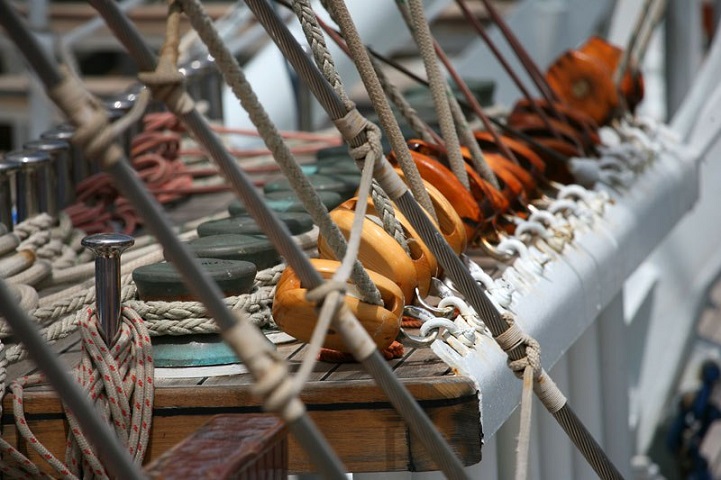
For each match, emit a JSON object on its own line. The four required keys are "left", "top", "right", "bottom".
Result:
{"left": 388, "top": 150, "right": 486, "bottom": 237}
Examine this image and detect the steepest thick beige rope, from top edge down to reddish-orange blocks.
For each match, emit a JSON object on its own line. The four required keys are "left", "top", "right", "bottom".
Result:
{"left": 396, "top": 0, "right": 470, "bottom": 189}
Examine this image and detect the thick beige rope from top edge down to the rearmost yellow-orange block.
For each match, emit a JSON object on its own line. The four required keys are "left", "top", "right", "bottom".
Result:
{"left": 321, "top": 0, "right": 438, "bottom": 221}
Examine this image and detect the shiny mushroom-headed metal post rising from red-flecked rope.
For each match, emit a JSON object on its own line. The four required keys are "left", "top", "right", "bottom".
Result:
{"left": 81, "top": 233, "right": 135, "bottom": 346}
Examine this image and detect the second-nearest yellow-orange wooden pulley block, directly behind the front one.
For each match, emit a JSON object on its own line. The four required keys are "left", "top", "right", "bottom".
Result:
{"left": 318, "top": 208, "right": 418, "bottom": 302}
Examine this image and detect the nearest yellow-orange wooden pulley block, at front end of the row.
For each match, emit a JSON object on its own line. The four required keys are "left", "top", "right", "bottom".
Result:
{"left": 272, "top": 258, "right": 405, "bottom": 352}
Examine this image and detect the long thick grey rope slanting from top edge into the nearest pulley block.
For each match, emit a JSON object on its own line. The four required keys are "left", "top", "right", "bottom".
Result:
{"left": 176, "top": 0, "right": 381, "bottom": 305}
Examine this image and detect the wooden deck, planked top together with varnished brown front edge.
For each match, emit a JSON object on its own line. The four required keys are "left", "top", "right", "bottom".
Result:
{"left": 2, "top": 332, "right": 481, "bottom": 472}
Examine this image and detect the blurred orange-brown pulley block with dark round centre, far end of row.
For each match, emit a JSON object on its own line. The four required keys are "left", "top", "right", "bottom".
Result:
{"left": 546, "top": 50, "right": 619, "bottom": 125}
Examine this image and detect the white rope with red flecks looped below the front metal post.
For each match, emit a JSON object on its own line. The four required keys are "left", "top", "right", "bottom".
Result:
{"left": 0, "top": 308, "right": 154, "bottom": 479}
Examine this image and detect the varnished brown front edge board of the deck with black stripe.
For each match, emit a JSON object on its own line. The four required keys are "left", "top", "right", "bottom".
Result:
{"left": 2, "top": 376, "right": 481, "bottom": 472}
